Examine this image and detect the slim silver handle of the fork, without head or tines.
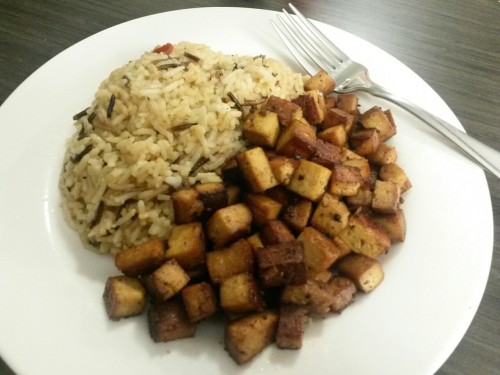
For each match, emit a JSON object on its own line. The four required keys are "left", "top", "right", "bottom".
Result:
{"left": 366, "top": 83, "right": 500, "bottom": 178}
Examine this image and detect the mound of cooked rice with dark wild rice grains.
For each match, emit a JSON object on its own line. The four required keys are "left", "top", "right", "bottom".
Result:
{"left": 60, "top": 42, "right": 305, "bottom": 254}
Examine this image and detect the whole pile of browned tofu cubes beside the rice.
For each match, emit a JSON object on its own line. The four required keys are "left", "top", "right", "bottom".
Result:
{"left": 104, "top": 72, "right": 411, "bottom": 364}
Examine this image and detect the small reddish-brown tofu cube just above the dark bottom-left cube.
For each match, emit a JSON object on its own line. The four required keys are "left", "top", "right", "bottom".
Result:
{"left": 181, "top": 281, "right": 217, "bottom": 322}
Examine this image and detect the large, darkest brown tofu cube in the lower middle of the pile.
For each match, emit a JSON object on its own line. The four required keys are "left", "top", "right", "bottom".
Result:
{"left": 256, "top": 240, "right": 307, "bottom": 287}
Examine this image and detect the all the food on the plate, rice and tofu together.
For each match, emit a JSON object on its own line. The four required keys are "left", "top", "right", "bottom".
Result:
{"left": 61, "top": 43, "right": 411, "bottom": 364}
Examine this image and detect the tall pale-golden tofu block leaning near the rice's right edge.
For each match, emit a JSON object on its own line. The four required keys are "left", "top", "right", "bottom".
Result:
{"left": 236, "top": 147, "right": 278, "bottom": 193}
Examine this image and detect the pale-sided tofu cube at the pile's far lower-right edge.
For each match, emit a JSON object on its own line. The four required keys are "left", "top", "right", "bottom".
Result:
{"left": 338, "top": 254, "right": 384, "bottom": 293}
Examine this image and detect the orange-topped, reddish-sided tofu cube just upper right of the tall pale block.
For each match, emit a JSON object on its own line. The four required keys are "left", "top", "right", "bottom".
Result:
{"left": 276, "top": 120, "right": 316, "bottom": 159}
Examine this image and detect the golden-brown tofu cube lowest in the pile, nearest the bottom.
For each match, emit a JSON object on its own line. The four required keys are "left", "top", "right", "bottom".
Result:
{"left": 224, "top": 311, "right": 278, "bottom": 365}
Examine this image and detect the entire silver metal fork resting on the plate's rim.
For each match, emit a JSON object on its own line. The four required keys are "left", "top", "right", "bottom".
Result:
{"left": 271, "top": 4, "right": 500, "bottom": 178}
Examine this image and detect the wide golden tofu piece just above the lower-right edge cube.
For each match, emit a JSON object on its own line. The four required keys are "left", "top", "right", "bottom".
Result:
{"left": 338, "top": 213, "right": 391, "bottom": 258}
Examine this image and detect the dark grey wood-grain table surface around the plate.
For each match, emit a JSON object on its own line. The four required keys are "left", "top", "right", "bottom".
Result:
{"left": 0, "top": 0, "right": 500, "bottom": 375}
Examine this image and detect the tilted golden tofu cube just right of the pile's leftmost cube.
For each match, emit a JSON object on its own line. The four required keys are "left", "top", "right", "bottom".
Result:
{"left": 144, "top": 259, "right": 190, "bottom": 301}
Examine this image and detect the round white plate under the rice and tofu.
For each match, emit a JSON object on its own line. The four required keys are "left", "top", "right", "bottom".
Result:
{"left": 0, "top": 8, "right": 493, "bottom": 375}
